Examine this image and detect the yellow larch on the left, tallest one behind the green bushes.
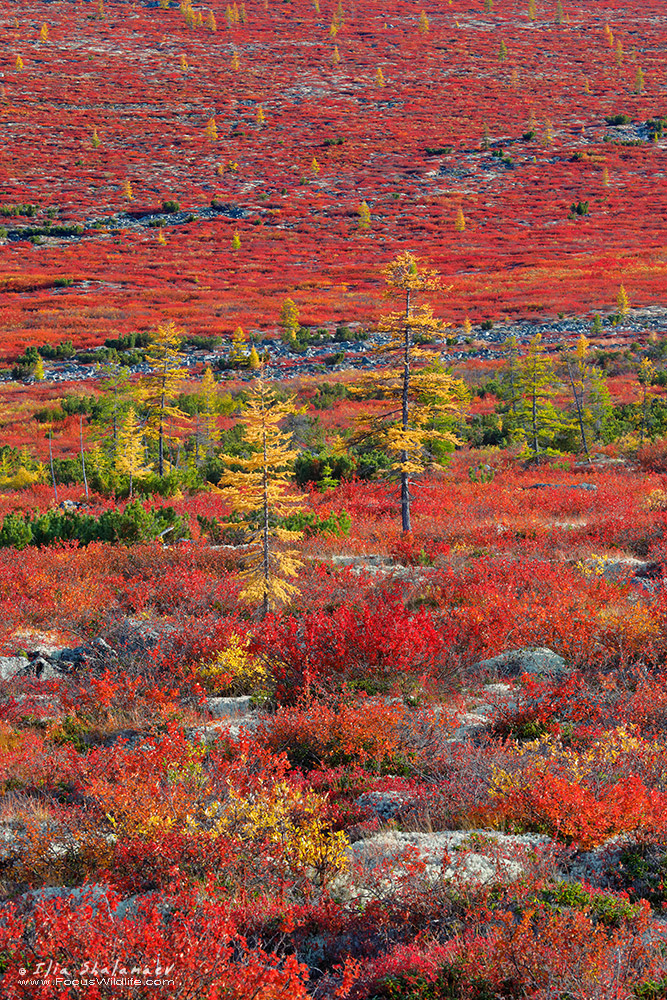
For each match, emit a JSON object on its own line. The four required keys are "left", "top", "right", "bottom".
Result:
{"left": 139, "top": 321, "right": 187, "bottom": 476}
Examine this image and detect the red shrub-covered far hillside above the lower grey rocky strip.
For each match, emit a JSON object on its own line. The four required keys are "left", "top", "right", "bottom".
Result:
{"left": 0, "top": 0, "right": 665, "bottom": 357}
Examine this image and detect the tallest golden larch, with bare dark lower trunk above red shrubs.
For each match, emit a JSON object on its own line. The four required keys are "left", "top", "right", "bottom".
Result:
{"left": 357, "top": 252, "right": 465, "bottom": 532}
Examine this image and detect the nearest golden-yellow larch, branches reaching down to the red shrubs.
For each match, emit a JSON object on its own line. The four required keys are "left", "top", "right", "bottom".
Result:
{"left": 220, "top": 370, "right": 303, "bottom": 617}
